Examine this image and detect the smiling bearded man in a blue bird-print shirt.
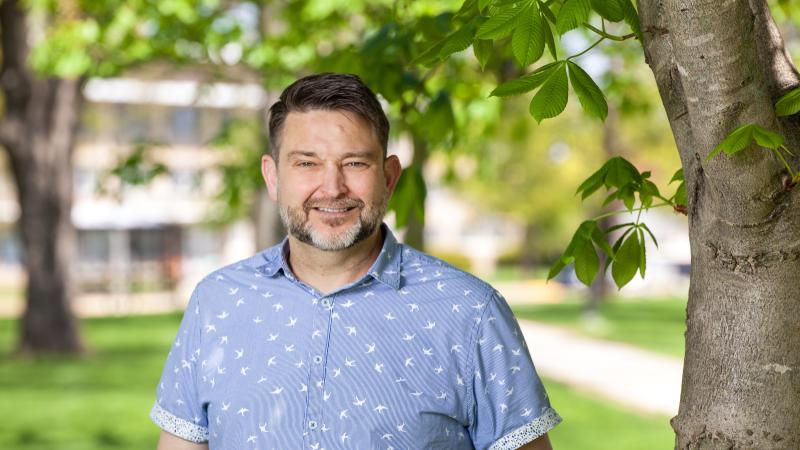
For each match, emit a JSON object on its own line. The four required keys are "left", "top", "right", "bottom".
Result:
{"left": 151, "top": 73, "right": 561, "bottom": 450}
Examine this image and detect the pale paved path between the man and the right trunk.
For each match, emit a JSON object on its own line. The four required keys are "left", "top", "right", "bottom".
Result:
{"left": 519, "top": 320, "right": 682, "bottom": 417}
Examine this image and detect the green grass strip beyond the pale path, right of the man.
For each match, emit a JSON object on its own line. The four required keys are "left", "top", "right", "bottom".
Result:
{"left": 514, "top": 299, "right": 686, "bottom": 358}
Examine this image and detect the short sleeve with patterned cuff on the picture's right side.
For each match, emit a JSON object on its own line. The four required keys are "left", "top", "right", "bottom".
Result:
{"left": 469, "top": 292, "right": 561, "bottom": 450}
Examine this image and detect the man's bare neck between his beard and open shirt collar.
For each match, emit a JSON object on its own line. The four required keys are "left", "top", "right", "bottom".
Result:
{"left": 289, "top": 227, "right": 383, "bottom": 294}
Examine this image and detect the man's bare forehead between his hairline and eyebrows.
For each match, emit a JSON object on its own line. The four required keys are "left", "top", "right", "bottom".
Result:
{"left": 281, "top": 109, "right": 382, "bottom": 155}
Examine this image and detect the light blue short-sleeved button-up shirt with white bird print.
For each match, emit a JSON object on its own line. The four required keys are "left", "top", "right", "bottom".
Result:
{"left": 150, "top": 225, "right": 561, "bottom": 450}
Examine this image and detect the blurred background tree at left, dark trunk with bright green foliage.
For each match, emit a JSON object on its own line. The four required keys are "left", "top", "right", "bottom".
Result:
{"left": 0, "top": 0, "right": 239, "bottom": 352}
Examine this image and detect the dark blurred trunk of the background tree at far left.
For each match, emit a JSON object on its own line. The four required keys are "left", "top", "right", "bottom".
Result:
{"left": 0, "top": 0, "right": 83, "bottom": 352}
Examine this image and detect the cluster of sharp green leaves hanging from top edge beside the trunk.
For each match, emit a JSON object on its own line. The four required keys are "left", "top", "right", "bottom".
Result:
{"left": 412, "top": 0, "right": 641, "bottom": 122}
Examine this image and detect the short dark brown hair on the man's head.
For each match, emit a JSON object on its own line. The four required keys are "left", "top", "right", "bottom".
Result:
{"left": 268, "top": 72, "right": 389, "bottom": 161}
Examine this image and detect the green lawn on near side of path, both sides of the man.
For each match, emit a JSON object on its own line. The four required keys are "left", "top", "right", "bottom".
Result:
{"left": 0, "top": 313, "right": 673, "bottom": 450}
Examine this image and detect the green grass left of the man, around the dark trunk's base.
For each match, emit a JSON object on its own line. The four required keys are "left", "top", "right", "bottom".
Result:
{"left": 0, "top": 315, "right": 180, "bottom": 450}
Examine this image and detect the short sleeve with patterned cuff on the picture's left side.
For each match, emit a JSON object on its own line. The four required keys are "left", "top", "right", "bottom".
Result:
{"left": 150, "top": 286, "right": 208, "bottom": 442}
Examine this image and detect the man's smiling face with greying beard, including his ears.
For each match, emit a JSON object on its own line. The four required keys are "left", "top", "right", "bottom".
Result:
{"left": 262, "top": 110, "right": 400, "bottom": 251}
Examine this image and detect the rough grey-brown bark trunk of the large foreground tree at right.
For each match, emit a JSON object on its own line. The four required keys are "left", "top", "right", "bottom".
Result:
{"left": 638, "top": 0, "right": 800, "bottom": 450}
